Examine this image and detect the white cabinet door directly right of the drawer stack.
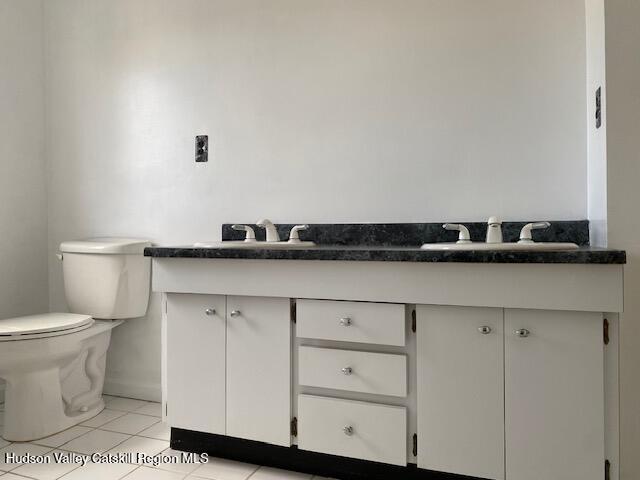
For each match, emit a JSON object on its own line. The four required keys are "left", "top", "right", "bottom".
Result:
{"left": 416, "top": 305, "right": 508, "bottom": 479}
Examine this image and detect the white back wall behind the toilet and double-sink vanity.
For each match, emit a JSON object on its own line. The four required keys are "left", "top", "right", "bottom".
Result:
{"left": 45, "top": 0, "right": 587, "bottom": 396}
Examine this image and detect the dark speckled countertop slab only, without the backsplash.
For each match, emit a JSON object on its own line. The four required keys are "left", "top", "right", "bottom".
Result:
{"left": 144, "top": 245, "right": 626, "bottom": 264}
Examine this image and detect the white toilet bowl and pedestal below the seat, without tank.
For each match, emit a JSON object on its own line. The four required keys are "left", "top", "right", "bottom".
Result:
{"left": 0, "top": 321, "right": 121, "bottom": 442}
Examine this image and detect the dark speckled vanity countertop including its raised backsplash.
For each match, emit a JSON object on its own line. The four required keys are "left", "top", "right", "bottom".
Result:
{"left": 144, "top": 220, "right": 626, "bottom": 264}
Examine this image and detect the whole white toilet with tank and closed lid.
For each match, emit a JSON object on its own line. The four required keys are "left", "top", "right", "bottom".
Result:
{"left": 0, "top": 238, "right": 151, "bottom": 441}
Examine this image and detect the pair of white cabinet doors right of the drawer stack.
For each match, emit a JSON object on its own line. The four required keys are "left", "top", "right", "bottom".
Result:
{"left": 416, "top": 306, "right": 605, "bottom": 480}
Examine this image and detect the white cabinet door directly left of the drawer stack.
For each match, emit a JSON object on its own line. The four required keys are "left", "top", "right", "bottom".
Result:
{"left": 227, "top": 297, "right": 291, "bottom": 446}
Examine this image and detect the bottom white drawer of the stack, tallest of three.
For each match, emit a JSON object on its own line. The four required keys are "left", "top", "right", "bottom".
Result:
{"left": 298, "top": 395, "right": 407, "bottom": 465}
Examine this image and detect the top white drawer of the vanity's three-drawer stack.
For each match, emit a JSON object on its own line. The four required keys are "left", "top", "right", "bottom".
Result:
{"left": 296, "top": 300, "right": 405, "bottom": 346}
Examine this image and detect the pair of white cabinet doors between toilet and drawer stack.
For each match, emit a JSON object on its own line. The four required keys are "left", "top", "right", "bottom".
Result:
{"left": 165, "top": 294, "right": 291, "bottom": 446}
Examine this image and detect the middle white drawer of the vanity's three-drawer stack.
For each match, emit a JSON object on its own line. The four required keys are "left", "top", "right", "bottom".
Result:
{"left": 298, "top": 347, "right": 407, "bottom": 397}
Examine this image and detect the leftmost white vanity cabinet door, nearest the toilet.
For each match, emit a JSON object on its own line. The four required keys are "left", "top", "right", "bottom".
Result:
{"left": 166, "top": 294, "right": 226, "bottom": 434}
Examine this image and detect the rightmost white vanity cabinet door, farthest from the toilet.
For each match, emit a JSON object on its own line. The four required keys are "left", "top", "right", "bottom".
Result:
{"left": 505, "top": 309, "right": 604, "bottom": 480}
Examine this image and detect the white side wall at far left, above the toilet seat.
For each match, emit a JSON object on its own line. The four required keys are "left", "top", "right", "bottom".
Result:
{"left": 0, "top": 0, "right": 48, "bottom": 318}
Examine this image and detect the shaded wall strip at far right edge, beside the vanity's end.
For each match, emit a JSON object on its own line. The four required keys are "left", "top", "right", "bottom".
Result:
{"left": 605, "top": 0, "right": 640, "bottom": 480}
